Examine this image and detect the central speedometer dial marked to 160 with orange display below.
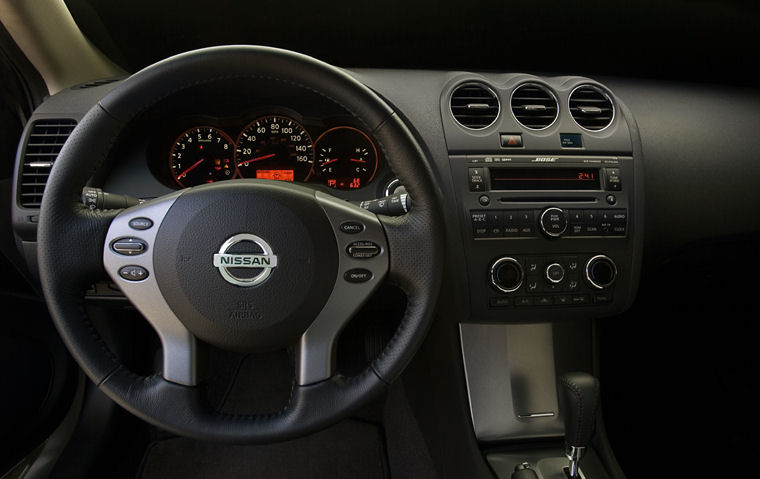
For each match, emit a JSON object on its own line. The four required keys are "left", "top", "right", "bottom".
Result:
{"left": 235, "top": 115, "right": 314, "bottom": 181}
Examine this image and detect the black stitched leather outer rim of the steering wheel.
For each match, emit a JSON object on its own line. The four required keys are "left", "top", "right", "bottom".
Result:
{"left": 38, "top": 46, "right": 443, "bottom": 443}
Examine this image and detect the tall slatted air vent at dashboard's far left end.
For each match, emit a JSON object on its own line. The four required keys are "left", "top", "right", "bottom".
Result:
{"left": 19, "top": 119, "right": 77, "bottom": 208}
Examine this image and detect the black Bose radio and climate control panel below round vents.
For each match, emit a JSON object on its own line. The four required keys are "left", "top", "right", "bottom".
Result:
{"left": 450, "top": 155, "right": 637, "bottom": 322}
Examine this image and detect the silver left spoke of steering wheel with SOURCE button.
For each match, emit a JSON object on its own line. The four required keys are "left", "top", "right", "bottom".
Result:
{"left": 103, "top": 194, "right": 198, "bottom": 386}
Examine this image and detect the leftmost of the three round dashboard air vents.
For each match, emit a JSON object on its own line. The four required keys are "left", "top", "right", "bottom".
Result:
{"left": 450, "top": 83, "right": 500, "bottom": 130}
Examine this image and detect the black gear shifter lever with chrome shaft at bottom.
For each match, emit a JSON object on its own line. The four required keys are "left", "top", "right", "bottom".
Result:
{"left": 560, "top": 372, "right": 599, "bottom": 479}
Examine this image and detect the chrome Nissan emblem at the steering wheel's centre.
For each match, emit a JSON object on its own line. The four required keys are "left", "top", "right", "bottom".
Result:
{"left": 214, "top": 233, "right": 277, "bottom": 288}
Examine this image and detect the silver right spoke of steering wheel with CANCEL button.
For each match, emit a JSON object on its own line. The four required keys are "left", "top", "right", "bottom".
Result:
{"left": 296, "top": 192, "right": 389, "bottom": 386}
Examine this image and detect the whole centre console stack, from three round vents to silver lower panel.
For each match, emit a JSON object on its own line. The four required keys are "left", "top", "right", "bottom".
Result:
{"left": 441, "top": 74, "right": 643, "bottom": 479}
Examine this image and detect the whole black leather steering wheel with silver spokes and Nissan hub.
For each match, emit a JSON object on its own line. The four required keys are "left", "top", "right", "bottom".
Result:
{"left": 38, "top": 46, "right": 443, "bottom": 443}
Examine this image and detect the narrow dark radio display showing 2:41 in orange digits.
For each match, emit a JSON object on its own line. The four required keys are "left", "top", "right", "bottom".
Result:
{"left": 490, "top": 168, "right": 601, "bottom": 190}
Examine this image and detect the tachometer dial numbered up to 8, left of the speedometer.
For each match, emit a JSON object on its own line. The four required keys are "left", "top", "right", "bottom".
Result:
{"left": 169, "top": 126, "right": 237, "bottom": 188}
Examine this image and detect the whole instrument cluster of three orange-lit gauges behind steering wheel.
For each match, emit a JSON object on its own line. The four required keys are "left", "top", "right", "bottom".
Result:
{"left": 160, "top": 114, "right": 381, "bottom": 190}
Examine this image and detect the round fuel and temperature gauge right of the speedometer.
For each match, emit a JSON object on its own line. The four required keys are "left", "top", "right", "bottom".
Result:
{"left": 314, "top": 126, "right": 377, "bottom": 190}
